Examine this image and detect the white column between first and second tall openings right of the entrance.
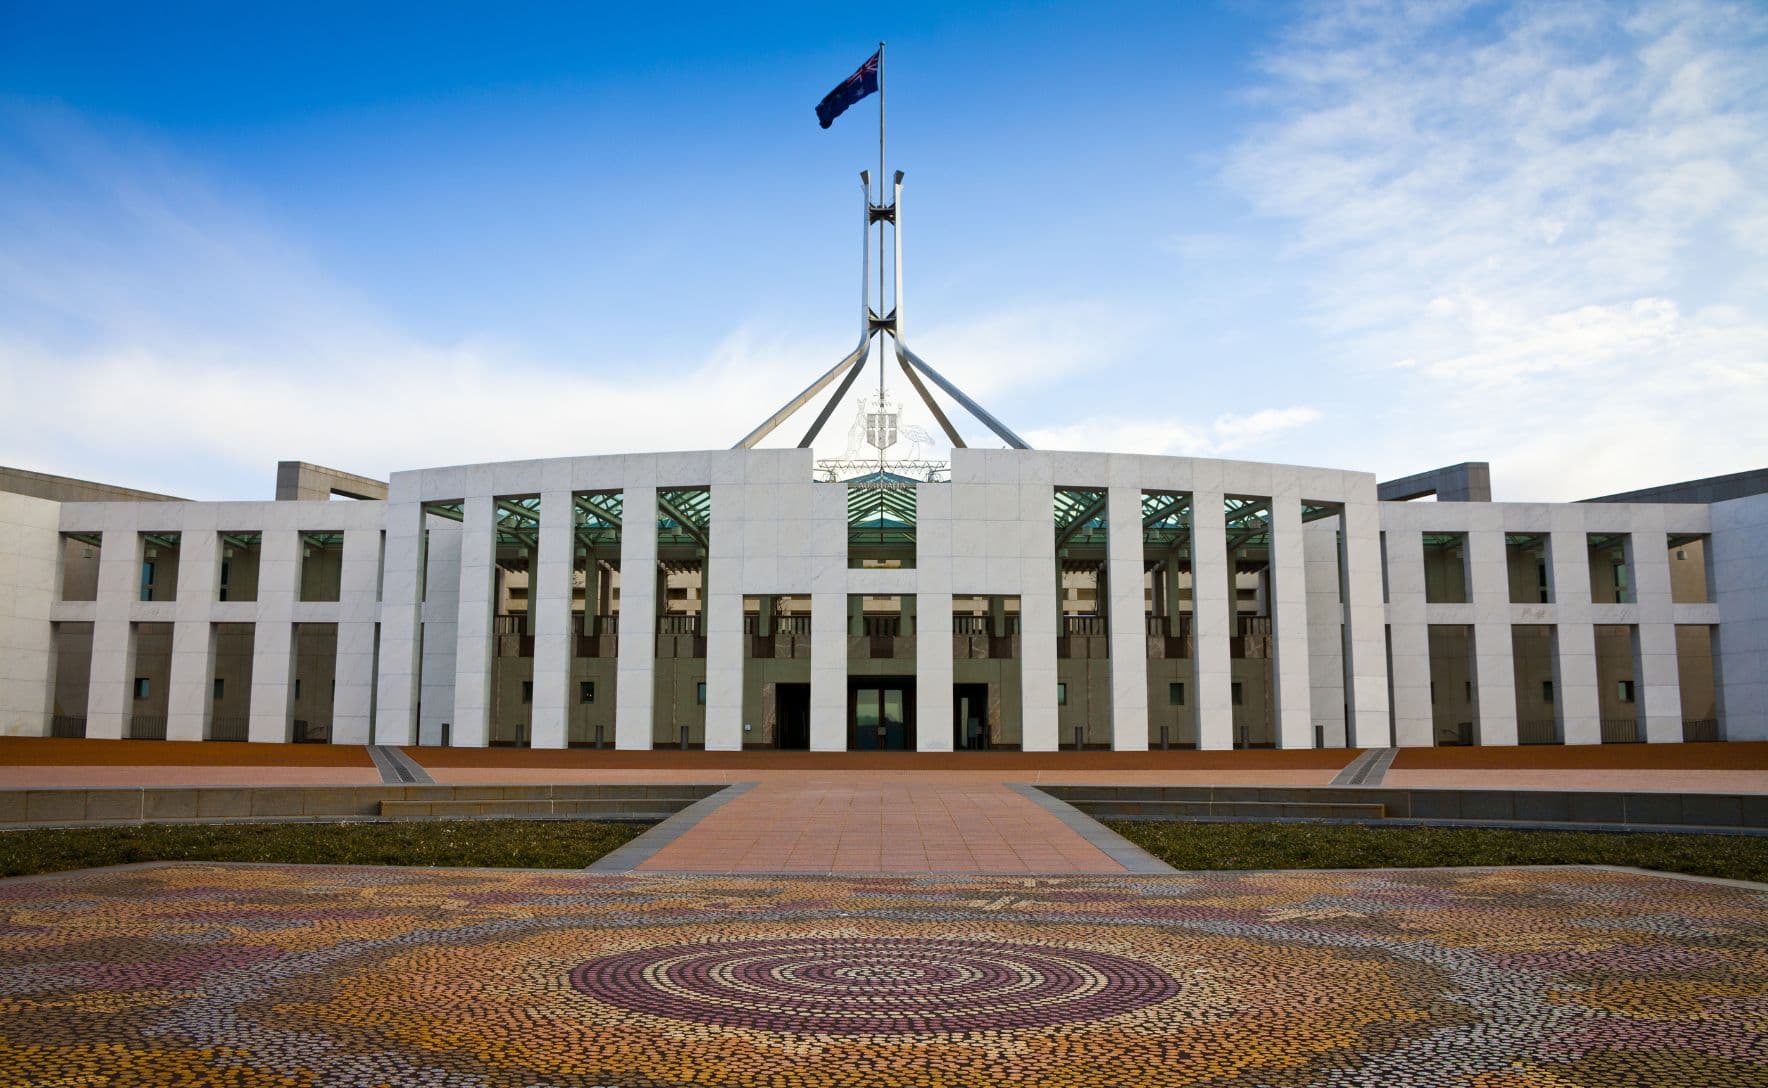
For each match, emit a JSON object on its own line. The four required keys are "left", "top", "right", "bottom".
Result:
{"left": 1105, "top": 487, "right": 1147, "bottom": 752}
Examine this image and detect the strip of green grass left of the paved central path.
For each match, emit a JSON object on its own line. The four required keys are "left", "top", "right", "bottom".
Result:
{"left": 0, "top": 819, "right": 647, "bottom": 876}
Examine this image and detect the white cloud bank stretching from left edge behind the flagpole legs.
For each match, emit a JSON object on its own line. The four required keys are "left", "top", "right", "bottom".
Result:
{"left": 0, "top": 103, "right": 1110, "bottom": 499}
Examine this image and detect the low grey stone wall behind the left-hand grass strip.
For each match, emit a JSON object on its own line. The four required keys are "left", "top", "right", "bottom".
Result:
{"left": 0, "top": 785, "right": 723, "bottom": 828}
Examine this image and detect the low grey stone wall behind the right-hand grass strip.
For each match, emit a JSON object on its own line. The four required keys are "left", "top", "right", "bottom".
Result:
{"left": 1038, "top": 785, "right": 1768, "bottom": 831}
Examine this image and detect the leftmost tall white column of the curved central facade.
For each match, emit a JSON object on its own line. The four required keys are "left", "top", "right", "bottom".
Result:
{"left": 373, "top": 502, "right": 424, "bottom": 745}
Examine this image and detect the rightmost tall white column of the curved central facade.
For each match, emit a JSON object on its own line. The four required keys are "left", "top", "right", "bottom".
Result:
{"left": 1344, "top": 495, "right": 1390, "bottom": 748}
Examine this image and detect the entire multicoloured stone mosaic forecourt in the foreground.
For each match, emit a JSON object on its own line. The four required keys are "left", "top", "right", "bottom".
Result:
{"left": 0, "top": 865, "right": 1768, "bottom": 1088}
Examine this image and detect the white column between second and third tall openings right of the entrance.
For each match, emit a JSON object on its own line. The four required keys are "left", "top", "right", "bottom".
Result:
{"left": 1188, "top": 488, "right": 1236, "bottom": 748}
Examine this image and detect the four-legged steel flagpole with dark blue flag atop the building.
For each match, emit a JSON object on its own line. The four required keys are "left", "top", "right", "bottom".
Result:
{"left": 732, "top": 42, "right": 1031, "bottom": 455}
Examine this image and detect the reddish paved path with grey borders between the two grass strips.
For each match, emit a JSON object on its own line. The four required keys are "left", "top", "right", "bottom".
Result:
{"left": 640, "top": 771, "right": 1123, "bottom": 872}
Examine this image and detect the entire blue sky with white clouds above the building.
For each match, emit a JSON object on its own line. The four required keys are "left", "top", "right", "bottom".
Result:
{"left": 0, "top": 0, "right": 1768, "bottom": 499}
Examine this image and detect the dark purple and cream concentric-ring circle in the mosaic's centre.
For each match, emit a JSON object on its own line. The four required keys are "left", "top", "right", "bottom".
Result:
{"left": 571, "top": 938, "right": 1179, "bottom": 1035}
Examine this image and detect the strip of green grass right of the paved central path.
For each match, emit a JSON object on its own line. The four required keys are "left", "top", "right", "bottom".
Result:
{"left": 1105, "top": 821, "right": 1768, "bottom": 881}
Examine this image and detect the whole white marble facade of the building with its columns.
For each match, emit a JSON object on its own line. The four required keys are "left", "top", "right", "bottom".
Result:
{"left": 0, "top": 449, "right": 1768, "bottom": 750}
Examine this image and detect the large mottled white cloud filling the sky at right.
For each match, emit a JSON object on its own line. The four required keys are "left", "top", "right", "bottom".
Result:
{"left": 1225, "top": 0, "right": 1768, "bottom": 497}
